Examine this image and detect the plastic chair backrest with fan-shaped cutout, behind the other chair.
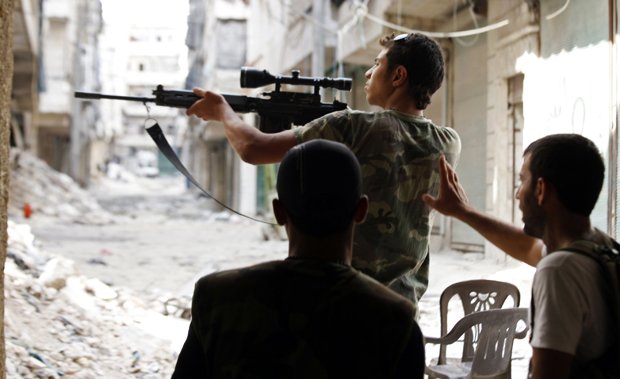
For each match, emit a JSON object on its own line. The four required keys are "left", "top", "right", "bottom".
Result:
{"left": 437, "top": 279, "right": 521, "bottom": 364}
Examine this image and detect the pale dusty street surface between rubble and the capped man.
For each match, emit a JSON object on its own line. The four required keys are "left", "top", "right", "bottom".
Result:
{"left": 24, "top": 177, "right": 286, "bottom": 302}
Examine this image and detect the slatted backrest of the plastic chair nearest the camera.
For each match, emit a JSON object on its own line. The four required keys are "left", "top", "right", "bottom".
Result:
{"left": 466, "top": 308, "right": 529, "bottom": 378}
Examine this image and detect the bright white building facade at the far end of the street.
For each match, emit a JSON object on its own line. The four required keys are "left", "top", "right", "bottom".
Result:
{"left": 100, "top": 1, "right": 187, "bottom": 177}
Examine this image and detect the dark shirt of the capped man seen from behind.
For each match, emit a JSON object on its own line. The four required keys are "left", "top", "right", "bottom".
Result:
{"left": 172, "top": 258, "right": 424, "bottom": 379}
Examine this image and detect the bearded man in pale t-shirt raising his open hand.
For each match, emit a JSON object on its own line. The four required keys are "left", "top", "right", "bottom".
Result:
{"left": 424, "top": 134, "right": 620, "bottom": 379}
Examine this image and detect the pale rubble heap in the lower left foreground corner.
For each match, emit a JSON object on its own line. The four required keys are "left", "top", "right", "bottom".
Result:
{"left": 5, "top": 220, "right": 188, "bottom": 378}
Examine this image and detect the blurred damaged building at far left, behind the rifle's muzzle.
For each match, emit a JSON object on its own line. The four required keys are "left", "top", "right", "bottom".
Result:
{"left": 11, "top": 0, "right": 102, "bottom": 185}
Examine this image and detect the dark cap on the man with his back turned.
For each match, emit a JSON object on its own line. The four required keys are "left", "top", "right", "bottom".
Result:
{"left": 276, "top": 139, "right": 362, "bottom": 236}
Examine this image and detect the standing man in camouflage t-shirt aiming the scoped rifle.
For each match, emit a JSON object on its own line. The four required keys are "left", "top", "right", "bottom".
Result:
{"left": 187, "top": 33, "right": 460, "bottom": 315}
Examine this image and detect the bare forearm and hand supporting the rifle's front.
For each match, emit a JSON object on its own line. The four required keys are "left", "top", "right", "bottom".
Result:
{"left": 186, "top": 88, "right": 297, "bottom": 164}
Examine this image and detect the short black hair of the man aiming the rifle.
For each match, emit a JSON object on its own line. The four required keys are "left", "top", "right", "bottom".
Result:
{"left": 380, "top": 33, "right": 445, "bottom": 109}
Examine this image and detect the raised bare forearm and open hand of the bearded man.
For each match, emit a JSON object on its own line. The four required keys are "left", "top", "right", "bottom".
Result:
{"left": 422, "top": 156, "right": 543, "bottom": 266}
